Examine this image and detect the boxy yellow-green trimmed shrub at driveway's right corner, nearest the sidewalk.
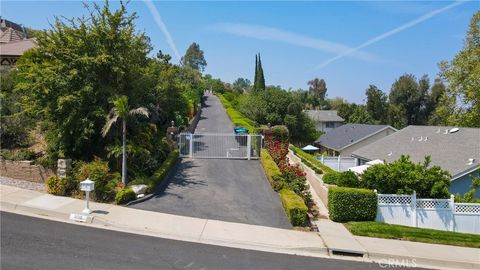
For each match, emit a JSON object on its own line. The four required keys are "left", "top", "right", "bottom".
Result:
{"left": 280, "top": 189, "right": 308, "bottom": 226}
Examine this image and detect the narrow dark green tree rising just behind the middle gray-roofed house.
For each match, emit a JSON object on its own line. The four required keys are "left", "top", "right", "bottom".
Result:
{"left": 365, "top": 85, "right": 388, "bottom": 124}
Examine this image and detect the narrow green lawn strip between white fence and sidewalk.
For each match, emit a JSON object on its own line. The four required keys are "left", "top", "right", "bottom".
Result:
{"left": 345, "top": 221, "right": 480, "bottom": 248}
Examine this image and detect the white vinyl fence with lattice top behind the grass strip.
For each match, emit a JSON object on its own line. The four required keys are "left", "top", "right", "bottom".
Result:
{"left": 375, "top": 192, "right": 480, "bottom": 234}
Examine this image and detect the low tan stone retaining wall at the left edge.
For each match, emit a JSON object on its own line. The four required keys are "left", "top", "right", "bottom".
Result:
{"left": 0, "top": 159, "right": 55, "bottom": 183}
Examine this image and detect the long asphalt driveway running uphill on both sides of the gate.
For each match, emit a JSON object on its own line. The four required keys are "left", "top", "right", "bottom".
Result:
{"left": 132, "top": 95, "right": 291, "bottom": 228}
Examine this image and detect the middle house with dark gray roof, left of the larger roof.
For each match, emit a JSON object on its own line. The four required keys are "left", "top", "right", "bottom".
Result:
{"left": 315, "top": 124, "right": 397, "bottom": 157}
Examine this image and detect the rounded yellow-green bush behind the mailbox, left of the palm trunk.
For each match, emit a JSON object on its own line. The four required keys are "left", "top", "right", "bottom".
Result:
{"left": 74, "top": 158, "right": 116, "bottom": 202}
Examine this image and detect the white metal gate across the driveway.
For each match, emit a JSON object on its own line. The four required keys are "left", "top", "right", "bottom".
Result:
{"left": 178, "top": 133, "right": 262, "bottom": 159}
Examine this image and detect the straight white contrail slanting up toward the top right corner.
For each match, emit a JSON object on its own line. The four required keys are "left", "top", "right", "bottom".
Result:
{"left": 315, "top": 1, "right": 468, "bottom": 69}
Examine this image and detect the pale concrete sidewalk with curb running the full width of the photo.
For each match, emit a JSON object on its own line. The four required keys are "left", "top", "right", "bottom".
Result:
{"left": 0, "top": 185, "right": 480, "bottom": 269}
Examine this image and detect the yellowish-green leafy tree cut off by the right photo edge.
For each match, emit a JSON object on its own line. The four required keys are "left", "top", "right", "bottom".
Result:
{"left": 437, "top": 11, "right": 480, "bottom": 127}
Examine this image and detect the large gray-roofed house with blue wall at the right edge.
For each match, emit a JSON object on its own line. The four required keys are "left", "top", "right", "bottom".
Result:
{"left": 352, "top": 126, "right": 480, "bottom": 197}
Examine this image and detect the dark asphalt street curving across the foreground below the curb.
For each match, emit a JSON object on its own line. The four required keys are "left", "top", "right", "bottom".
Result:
{"left": 0, "top": 212, "right": 379, "bottom": 270}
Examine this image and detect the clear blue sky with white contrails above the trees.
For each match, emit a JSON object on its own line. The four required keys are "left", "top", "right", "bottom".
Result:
{"left": 0, "top": 0, "right": 480, "bottom": 102}
